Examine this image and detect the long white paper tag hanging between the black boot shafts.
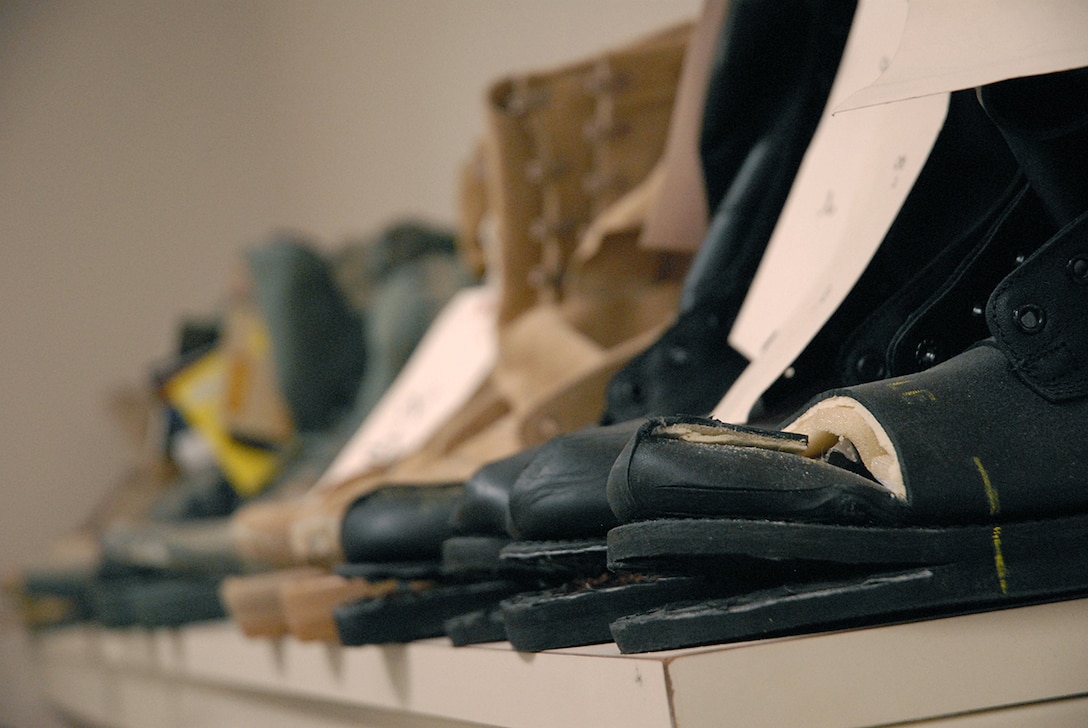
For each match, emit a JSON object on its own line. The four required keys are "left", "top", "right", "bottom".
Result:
{"left": 714, "top": 0, "right": 948, "bottom": 422}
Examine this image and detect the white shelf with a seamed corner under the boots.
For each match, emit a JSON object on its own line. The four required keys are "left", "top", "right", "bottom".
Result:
{"left": 35, "top": 600, "right": 1088, "bottom": 728}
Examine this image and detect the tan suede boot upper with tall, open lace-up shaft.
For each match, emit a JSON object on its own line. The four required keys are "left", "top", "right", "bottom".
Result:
{"left": 227, "top": 25, "right": 691, "bottom": 591}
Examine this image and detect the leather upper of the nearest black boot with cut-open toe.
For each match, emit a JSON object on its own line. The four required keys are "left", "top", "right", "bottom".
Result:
{"left": 609, "top": 66, "right": 1088, "bottom": 563}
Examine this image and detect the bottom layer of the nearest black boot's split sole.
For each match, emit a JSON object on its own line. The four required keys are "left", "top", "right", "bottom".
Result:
{"left": 611, "top": 519, "right": 1088, "bottom": 653}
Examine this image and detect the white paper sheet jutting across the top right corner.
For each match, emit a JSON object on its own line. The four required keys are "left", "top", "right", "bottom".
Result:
{"left": 837, "top": 0, "right": 1088, "bottom": 111}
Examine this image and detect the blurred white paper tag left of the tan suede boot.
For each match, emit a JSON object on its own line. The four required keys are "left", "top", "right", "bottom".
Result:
{"left": 313, "top": 286, "right": 498, "bottom": 492}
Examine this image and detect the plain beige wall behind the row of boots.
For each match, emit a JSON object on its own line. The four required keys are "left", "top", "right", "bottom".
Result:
{"left": 0, "top": 0, "right": 700, "bottom": 726}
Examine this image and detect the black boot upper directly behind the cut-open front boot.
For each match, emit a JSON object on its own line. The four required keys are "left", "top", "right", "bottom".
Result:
{"left": 510, "top": 85, "right": 1031, "bottom": 561}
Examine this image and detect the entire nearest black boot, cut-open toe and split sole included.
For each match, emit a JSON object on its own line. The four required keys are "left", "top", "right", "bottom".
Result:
{"left": 608, "top": 70, "right": 1088, "bottom": 651}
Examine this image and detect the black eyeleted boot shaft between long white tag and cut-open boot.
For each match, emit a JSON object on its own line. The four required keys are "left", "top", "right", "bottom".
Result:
{"left": 752, "top": 90, "right": 1055, "bottom": 424}
